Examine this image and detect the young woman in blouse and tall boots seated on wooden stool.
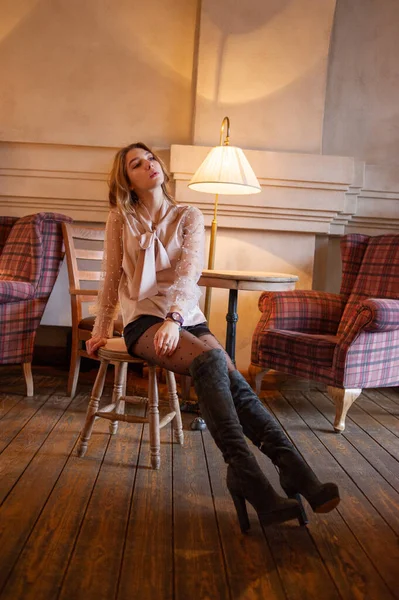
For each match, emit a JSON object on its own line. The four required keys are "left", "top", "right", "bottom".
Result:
{"left": 86, "top": 143, "right": 339, "bottom": 532}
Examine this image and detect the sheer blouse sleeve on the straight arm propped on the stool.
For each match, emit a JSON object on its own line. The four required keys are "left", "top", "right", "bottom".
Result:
{"left": 92, "top": 211, "right": 123, "bottom": 337}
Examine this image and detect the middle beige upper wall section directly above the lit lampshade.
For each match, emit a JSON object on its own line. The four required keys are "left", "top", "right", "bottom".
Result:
{"left": 194, "top": 0, "right": 335, "bottom": 153}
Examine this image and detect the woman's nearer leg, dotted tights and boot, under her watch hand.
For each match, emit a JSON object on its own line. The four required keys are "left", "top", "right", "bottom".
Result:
{"left": 131, "top": 323, "right": 300, "bottom": 532}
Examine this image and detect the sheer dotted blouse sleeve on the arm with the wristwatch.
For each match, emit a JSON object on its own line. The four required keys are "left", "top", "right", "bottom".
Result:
{"left": 167, "top": 206, "right": 205, "bottom": 317}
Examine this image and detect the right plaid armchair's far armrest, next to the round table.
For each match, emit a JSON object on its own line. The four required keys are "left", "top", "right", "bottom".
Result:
{"left": 258, "top": 290, "right": 346, "bottom": 335}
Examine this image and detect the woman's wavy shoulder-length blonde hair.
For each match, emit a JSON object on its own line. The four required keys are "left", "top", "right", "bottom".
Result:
{"left": 108, "top": 142, "right": 176, "bottom": 213}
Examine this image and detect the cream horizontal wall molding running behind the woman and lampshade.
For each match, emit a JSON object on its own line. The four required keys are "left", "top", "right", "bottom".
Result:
{"left": 0, "top": 142, "right": 399, "bottom": 235}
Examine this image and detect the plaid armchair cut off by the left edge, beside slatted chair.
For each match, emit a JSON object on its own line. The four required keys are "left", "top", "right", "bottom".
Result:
{"left": 0, "top": 213, "right": 71, "bottom": 396}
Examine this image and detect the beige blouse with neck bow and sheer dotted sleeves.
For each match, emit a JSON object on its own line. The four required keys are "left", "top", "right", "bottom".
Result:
{"left": 92, "top": 200, "right": 205, "bottom": 337}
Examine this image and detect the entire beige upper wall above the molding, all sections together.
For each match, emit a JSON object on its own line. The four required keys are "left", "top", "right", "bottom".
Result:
{"left": 0, "top": 0, "right": 399, "bottom": 164}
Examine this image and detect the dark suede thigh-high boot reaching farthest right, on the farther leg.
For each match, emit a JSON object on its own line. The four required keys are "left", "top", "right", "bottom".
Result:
{"left": 229, "top": 371, "right": 340, "bottom": 513}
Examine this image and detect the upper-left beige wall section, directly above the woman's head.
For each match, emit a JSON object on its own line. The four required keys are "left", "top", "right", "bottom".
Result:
{"left": 0, "top": 0, "right": 197, "bottom": 147}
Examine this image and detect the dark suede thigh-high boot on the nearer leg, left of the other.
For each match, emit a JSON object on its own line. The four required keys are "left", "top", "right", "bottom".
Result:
{"left": 190, "top": 348, "right": 301, "bottom": 533}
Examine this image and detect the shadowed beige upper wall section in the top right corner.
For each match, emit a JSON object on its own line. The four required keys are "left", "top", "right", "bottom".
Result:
{"left": 323, "top": 0, "right": 399, "bottom": 165}
